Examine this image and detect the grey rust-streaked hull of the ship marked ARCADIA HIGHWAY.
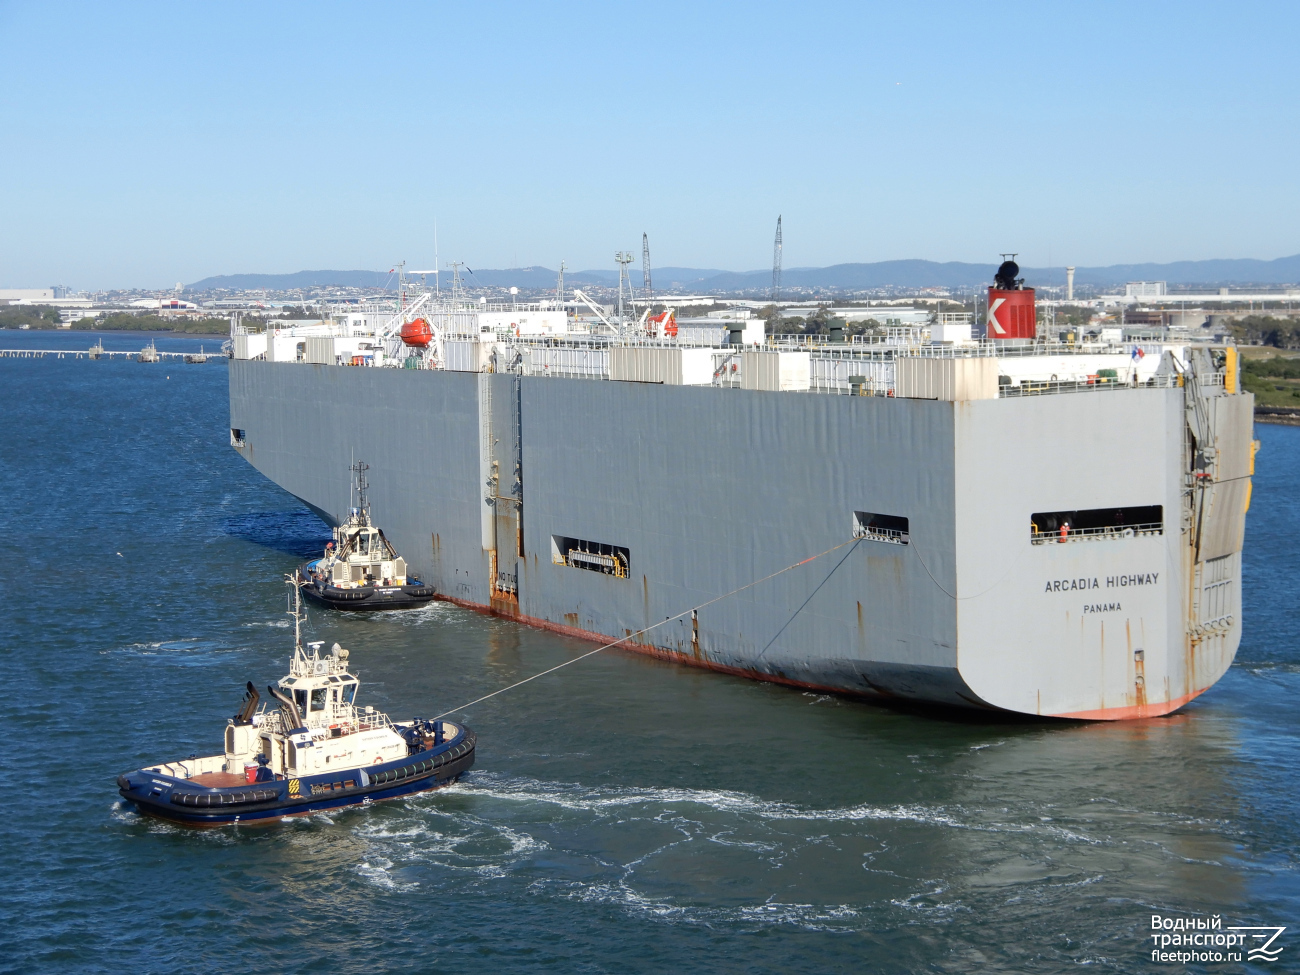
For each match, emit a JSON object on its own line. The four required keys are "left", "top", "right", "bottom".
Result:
{"left": 230, "top": 359, "right": 1251, "bottom": 718}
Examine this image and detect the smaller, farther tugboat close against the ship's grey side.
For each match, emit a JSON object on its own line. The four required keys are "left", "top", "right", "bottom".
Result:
{"left": 298, "top": 463, "right": 434, "bottom": 610}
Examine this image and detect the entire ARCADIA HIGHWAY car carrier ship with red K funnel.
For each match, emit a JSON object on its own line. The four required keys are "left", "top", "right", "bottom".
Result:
{"left": 230, "top": 268, "right": 1257, "bottom": 719}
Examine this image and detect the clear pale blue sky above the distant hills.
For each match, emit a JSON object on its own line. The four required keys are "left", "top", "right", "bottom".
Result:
{"left": 0, "top": 0, "right": 1300, "bottom": 287}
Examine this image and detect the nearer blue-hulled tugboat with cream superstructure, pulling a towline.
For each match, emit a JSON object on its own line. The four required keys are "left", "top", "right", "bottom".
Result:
{"left": 117, "top": 579, "right": 476, "bottom": 826}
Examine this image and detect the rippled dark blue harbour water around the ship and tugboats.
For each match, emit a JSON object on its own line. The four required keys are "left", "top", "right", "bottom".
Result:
{"left": 0, "top": 332, "right": 1300, "bottom": 972}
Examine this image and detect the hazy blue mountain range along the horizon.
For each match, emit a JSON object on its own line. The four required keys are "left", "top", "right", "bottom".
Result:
{"left": 186, "top": 255, "right": 1300, "bottom": 294}
